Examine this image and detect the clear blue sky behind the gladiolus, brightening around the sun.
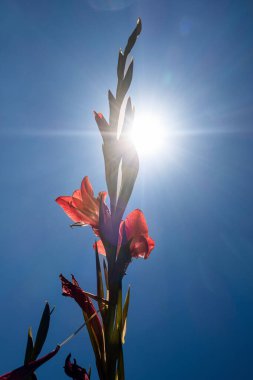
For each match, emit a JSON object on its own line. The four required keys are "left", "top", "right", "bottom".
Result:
{"left": 0, "top": 0, "right": 253, "bottom": 380}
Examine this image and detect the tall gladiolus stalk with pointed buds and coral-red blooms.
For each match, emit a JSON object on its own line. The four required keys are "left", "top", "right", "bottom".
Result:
{"left": 56, "top": 19, "right": 154, "bottom": 380}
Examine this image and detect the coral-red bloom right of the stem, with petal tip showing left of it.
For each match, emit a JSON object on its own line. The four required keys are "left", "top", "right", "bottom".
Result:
{"left": 97, "top": 209, "right": 155, "bottom": 259}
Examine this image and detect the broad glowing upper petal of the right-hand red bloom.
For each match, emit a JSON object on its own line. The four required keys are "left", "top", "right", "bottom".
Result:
{"left": 125, "top": 209, "right": 148, "bottom": 240}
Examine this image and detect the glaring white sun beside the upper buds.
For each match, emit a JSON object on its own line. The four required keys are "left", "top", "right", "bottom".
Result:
{"left": 132, "top": 112, "right": 166, "bottom": 156}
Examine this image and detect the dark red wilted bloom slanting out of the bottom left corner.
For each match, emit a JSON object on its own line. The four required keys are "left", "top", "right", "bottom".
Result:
{"left": 0, "top": 346, "right": 60, "bottom": 380}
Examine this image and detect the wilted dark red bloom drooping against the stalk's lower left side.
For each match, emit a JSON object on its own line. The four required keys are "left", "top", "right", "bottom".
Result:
{"left": 60, "top": 274, "right": 104, "bottom": 356}
